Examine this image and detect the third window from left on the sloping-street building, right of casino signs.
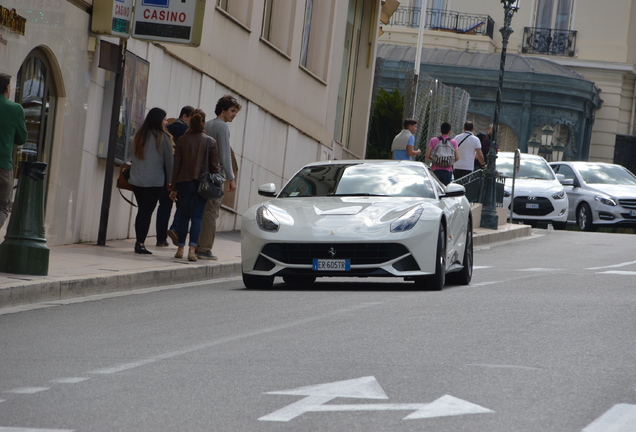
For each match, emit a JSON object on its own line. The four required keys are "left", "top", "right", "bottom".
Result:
{"left": 300, "top": 0, "right": 334, "bottom": 80}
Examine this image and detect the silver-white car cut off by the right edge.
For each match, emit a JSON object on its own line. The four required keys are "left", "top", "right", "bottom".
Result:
{"left": 550, "top": 162, "right": 636, "bottom": 231}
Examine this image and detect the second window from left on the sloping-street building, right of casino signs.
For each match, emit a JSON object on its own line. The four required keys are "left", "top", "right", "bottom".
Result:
{"left": 261, "top": 0, "right": 296, "bottom": 57}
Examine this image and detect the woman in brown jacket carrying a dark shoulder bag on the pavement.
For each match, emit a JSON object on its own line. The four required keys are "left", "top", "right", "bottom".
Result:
{"left": 170, "top": 109, "right": 219, "bottom": 261}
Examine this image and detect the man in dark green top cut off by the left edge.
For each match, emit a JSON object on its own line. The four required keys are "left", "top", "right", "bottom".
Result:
{"left": 0, "top": 73, "right": 27, "bottom": 228}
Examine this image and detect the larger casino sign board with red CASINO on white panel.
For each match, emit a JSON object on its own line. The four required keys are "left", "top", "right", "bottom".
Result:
{"left": 132, "top": 0, "right": 205, "bottom": 47}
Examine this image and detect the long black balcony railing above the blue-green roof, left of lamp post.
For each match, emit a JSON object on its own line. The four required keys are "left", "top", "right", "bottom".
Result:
{"left": 389, "top": 6, "right": 495, "bottom": 39}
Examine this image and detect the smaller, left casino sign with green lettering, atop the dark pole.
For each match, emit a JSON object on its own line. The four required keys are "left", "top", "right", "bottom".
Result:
{"left": 91, "top": 0, "right": 133, "bottom": 39}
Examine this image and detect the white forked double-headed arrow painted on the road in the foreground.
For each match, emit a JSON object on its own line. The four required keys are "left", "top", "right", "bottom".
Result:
{"left": 259, "top": 376, "right": 493, "bottom": 422}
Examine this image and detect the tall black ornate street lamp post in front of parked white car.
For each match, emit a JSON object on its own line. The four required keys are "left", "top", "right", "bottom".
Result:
{"left": 480, "top": 0, "right": 520, "bottom": 229}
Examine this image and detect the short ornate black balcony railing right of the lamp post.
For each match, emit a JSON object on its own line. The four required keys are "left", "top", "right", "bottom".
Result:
{"left": 521, "top": 27, "right": 576, "bottom": 57}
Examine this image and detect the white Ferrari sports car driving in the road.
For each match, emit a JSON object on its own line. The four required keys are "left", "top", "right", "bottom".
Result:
{"left": 241, "top": 160, "right": 473, "bottom": 290}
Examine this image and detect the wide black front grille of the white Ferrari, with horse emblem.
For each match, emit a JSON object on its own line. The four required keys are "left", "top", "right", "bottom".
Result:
{"left": 262, "top": 243, "right": 408, "bottom": 265}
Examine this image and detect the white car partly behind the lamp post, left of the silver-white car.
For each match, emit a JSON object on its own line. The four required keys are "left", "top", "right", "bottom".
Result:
{"left": 497, "top": 152, "right": 568, "bottom": 229}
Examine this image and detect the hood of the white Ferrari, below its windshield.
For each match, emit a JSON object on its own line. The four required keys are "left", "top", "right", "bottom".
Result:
{"left": 264, "top": 197, "right": 442, "bottom": 230}
